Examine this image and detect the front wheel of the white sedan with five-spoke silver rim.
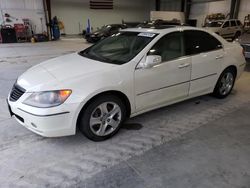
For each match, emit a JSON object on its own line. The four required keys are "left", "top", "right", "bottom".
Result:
{"left": 79, "top": 95, "right": 126, "bottom": 141}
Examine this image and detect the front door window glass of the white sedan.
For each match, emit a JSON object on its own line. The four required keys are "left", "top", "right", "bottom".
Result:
{"left": 148, "top": 32, "right": 184, "bottom": 62}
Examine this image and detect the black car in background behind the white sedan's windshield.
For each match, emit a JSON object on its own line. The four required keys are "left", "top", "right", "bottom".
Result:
{"left": 85, "top": 24, "right": 127, "bottom": 43}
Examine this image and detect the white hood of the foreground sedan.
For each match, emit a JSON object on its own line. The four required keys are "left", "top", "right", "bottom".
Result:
{"left": 18, "top": 53, "right": 114, "bottom": 90}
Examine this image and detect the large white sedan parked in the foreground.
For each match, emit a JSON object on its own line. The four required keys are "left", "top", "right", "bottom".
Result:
{"left": 8, "top": 27, "right": 246, "bottom": 141}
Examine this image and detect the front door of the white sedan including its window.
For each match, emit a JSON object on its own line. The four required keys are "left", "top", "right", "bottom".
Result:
{"left": 135, "top": 32, "right": 191, "bottom": 112}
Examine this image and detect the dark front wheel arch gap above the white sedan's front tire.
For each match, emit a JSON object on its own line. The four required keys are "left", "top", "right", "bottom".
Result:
{"left": 76, "top": 90, "right": 131, "bottom": 126}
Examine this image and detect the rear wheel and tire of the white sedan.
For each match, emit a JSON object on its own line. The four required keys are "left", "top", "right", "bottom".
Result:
{"left": 213, "top": 68, "right": 236, "bottom": 99}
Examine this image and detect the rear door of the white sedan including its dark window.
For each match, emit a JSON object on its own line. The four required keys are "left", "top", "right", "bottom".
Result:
{"left": 184, "top": 30, "right": 224, "bottom": 96}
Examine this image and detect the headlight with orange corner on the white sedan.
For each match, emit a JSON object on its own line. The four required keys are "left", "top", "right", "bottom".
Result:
{"left": 23, "top": 90, "right": 72, "bottom": 108}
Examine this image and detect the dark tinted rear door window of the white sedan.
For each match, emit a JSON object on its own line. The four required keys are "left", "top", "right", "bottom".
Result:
{"left": 184, "top": 30, "right": 222, "bottom": 55}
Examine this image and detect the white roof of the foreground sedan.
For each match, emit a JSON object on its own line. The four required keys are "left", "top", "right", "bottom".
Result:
{"left": 122, "top": 26, "right": 207, "bottom": 34}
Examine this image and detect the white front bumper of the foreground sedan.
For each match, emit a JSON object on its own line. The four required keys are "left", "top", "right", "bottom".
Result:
{"left": 7, "top": 94, "right": 78, "bottom": 137}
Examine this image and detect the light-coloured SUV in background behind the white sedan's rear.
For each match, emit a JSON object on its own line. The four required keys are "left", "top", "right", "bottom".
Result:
{"left": 205, "top": 19, "right": 243, "bottom": 40}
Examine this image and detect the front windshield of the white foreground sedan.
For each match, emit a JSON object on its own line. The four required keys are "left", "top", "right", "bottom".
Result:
{"left": 79, "top": 32, "right": 157, "bottom": 65}
